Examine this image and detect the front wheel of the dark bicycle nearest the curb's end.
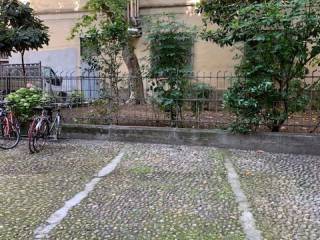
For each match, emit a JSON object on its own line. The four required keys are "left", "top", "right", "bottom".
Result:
{"left": 32, "top": 119, "right": 50, "bottom": 152}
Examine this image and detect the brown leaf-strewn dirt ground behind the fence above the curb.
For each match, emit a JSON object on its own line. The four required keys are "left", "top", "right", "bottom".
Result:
{"left": 62, "top": 104, "right": 320, "bottom": 134}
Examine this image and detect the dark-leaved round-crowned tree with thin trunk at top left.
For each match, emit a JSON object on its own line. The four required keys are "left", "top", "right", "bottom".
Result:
{"left": 0, "top": 0, "right": 49, "bottom": 83}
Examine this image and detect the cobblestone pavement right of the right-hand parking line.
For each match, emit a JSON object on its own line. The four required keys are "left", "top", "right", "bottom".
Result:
{"left": 232, "top": 151, "right": 320, "bottom": 240}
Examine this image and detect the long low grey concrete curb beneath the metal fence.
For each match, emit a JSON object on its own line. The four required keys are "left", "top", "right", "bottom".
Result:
{"left": 62, "top": 124, "right": 320, "bottom": 155}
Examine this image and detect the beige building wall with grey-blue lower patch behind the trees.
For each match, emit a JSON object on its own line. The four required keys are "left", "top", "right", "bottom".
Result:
{"left": 15, "top": 0, "right": 234, "bottom": 77}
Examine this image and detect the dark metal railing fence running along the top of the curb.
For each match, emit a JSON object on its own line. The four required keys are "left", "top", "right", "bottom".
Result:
{"left": 0, "top": 71, "right": 320, "bottom": 133}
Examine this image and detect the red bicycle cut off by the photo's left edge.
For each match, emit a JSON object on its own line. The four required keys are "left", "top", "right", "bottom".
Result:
{"left": 0, "top": 101, "right": 20, "bottom": 150}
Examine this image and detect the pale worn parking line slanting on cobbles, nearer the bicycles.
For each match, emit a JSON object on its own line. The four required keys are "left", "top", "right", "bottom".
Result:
{"left": 34, "top": 151, "right": 124, "bottom": 239}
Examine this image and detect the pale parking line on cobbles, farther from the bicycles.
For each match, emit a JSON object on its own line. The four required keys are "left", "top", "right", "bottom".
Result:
{"left": 225, "top": 158, "right": 262, "bottom": 240}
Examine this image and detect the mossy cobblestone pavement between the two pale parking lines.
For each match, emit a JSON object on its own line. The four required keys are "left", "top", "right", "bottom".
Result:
{"left": 51, "top": 144, "right": 244, "bottom": 240}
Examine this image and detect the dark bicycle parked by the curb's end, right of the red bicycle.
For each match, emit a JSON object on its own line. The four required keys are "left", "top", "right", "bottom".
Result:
{"left": 28, "top": 106, "right": 61, "bottom": 153}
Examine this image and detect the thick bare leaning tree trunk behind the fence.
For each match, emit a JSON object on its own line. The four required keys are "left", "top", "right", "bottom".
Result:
{"left": 122, "top": 40, "right": 145, "bottom": 104}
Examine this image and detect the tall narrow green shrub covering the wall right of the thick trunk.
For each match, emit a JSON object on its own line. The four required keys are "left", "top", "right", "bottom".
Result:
{"left": 147, "top": 15, "right": 196, "bottom": 120}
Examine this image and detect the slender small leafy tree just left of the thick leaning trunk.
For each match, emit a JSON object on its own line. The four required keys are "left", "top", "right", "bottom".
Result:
{"left": 74, "top": 16, "right": 127, "bottom": 103}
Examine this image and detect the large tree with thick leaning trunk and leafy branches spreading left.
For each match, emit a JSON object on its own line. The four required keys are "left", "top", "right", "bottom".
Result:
{"left": 72, "top": 0, "right": 145, "bottom": 104}
